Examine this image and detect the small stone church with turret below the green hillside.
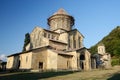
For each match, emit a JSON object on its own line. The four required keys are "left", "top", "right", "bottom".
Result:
{"left": 91, "top": 43, "right": 111, "bottom": 69}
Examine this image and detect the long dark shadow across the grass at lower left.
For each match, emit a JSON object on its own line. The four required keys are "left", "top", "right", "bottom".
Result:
{"left": 0, "top": 71, "right": 73, "bottom": 80}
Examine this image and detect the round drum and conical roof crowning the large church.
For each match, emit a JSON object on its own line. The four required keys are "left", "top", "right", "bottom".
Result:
{"left": 48, "top": 8, "right": 74, "bottom": 31}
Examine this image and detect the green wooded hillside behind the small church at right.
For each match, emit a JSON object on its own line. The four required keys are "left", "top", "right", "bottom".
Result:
{"left": 90, "top": 26, "right": 120, "bottom": 56}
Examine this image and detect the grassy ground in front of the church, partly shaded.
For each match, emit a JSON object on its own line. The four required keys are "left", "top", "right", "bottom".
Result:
{"left": 0, "top": 66, "right": 120, "bottom": 80}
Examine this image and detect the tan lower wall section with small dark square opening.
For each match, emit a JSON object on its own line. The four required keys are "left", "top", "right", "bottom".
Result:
{"left": 32, "top": 48, "right": 47, "bottom": 70}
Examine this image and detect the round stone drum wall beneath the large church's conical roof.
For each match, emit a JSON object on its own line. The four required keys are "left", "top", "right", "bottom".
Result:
{"left": 48, "top": 15, "right": 74, "bottom": 31}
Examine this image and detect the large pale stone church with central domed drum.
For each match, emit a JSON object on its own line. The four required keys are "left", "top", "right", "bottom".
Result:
{"left": 7, "top": 9, "right": 91, "bottom": 70}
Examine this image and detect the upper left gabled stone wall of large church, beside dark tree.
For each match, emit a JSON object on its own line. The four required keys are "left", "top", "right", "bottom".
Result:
{"left": 30, "top": 27, "right": 49, "bottom": 49}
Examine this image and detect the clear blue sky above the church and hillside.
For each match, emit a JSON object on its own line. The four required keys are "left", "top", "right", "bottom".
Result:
{"left": 0, "top": 0, "right": 120, "bottom": 59}
